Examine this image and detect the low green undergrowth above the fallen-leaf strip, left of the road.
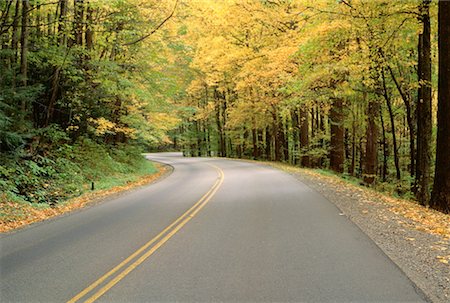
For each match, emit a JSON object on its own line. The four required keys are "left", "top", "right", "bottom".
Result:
{"left": 0, "top": 128, "right": 156, "bottom": 205}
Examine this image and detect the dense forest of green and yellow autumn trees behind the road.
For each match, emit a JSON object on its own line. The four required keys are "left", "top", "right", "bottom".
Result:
{"left": 0, "top": 0, "right": 450, "bottom": 213}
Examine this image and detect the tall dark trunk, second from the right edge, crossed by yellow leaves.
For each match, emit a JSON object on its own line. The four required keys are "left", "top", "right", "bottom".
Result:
{"left": 416, "top": 0, "right": 432, "bottom": 205}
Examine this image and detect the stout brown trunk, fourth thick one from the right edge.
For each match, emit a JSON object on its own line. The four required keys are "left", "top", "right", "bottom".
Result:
{"left": 330, "top": 98, "right": 344, "bottom": 173}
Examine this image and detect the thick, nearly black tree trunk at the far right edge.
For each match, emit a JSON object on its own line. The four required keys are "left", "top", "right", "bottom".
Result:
{"left": 430, "top": 0, "right": 450, "bottom": 213}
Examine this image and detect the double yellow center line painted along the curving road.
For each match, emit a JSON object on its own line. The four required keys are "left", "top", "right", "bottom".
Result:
{"left": 68, "top": 164, "right": 224, "bottom": 303}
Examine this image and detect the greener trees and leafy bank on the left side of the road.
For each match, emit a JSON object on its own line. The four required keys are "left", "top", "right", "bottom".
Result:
{"left": 0, "top": 0, "right": 183, "bottom": 226}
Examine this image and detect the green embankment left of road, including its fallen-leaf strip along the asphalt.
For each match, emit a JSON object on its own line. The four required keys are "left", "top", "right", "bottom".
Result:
{"left": 0, "top": 139, "right": 166, "bottom": 232}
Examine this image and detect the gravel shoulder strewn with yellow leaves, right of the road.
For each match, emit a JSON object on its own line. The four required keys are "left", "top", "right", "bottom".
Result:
{"left": 269, "top": 163, "right": 450, "bottom": 303}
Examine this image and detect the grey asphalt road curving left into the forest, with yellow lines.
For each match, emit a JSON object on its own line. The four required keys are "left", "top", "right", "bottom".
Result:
{"left": 0, "top": 153, "right": 425, "bottom": 302}
